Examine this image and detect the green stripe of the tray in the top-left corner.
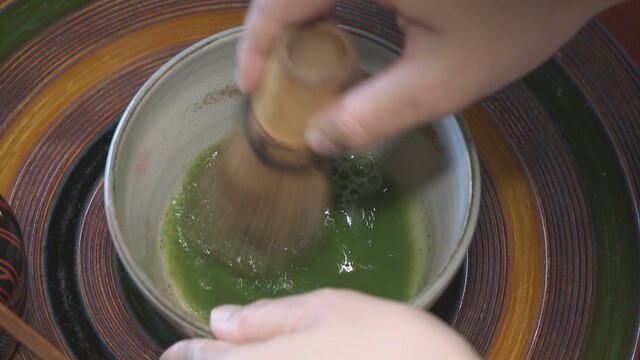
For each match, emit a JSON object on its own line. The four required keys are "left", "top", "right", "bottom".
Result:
{"left": 0, "top": 0, "right": 92, "bottom": 62}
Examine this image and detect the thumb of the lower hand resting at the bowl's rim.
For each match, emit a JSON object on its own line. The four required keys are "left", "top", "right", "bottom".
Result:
{"left": 210, "top": 296, "right": 312, "bottom": 344}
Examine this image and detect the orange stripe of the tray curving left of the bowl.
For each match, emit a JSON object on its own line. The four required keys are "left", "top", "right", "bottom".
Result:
{"left": 0, "top": 10, "right": 244, "bottom": 193}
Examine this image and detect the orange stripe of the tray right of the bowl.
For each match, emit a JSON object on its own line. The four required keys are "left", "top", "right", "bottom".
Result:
{"left": 464, "top": 106, "right": 546, "bottom": 359}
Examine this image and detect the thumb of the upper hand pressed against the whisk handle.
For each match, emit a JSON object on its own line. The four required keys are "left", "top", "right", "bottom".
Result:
{"left": 305, "top": 51, "right": 466, "bottom": 155}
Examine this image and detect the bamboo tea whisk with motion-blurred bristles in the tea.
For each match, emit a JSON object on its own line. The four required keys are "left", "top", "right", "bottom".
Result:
{"left": 196, "top": 22, "right": 360, "bottom": 274}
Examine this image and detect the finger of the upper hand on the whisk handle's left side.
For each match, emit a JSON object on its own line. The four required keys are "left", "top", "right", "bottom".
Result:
{"left": 237, "top": 0, "right": 337, "bottom": 93}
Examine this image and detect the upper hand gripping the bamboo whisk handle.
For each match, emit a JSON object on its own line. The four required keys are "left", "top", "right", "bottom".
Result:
{"left": 238, "top": 0, "right": 620, "bottom": 155}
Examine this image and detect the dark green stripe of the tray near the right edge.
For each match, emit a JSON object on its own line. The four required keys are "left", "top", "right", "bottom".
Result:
{"left": 526, "top": 61, "right": 640, "bottom": 359}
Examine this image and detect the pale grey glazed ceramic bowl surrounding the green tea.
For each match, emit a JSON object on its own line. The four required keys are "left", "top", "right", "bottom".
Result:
{"left": 105, "top": 28, "right": 480, "bottom": 336}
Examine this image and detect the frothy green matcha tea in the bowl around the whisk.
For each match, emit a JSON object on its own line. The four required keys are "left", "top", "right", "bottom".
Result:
{"left": 161, "top": 144, "right": 430, "bottom": 321}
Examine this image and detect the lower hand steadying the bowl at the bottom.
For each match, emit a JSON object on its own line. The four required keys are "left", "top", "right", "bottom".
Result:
{"left": 161, "top": 289, "right": 478, "bottom": 360}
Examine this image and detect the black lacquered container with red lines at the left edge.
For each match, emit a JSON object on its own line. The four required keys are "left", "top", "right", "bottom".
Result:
{"left": 0, "top": 196, "right": 27, "bottom": 360}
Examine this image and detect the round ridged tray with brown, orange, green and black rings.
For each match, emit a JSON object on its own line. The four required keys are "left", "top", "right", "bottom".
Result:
{"left": 0, "top": 0, "right": 640, "bottom": 359}
